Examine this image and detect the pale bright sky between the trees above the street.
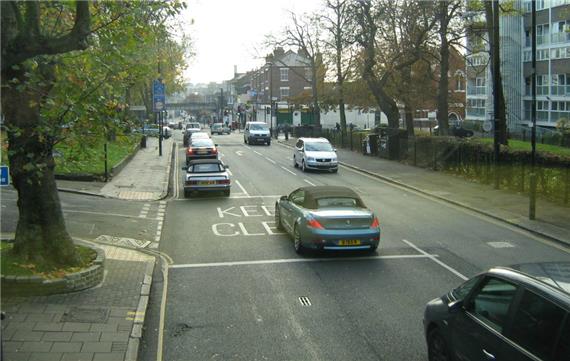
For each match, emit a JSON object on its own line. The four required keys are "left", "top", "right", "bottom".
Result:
{"left": 181, "top": 0, "right": 323, "bottom": 83}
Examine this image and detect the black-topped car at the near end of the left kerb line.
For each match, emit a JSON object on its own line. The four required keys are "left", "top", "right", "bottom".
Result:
{"left": 184, "top": 159, "right": 231, "bottom": 198}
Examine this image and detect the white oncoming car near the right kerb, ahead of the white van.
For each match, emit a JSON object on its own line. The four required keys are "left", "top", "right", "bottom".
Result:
{"left": 293, "top": 138, "right": 338, "bottom": 173}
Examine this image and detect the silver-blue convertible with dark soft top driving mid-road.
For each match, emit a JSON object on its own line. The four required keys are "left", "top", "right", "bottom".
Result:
{"left": 275, "top": 186, "right": 380, "bottom": 253}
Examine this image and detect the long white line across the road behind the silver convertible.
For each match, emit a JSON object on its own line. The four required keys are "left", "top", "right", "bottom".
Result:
{"left": 169, "top": 253, "right": 437, "bottom": 268}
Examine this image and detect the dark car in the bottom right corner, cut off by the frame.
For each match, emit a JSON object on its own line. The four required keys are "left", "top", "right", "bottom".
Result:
{"left": 424, "top": 262, "right": 570, "bottom": 361}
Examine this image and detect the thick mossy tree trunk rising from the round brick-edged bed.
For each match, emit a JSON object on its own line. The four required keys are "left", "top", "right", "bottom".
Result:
{"left": 2, "top": 65, "right": 78, "bottom": 266}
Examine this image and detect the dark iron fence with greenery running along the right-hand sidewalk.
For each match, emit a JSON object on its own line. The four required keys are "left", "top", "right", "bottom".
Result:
{"left": 293, "top": 126, "right": 570, "bottom": 205}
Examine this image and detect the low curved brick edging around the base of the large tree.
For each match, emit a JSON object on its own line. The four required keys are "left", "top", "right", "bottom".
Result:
{"left": 0, "top": 241, "right": 105, "bottom": 297}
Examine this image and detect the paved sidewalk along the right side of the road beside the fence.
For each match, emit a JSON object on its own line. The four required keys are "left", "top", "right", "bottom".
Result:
{"left": 279, "top": 137, "right": 570, "bottom": 245}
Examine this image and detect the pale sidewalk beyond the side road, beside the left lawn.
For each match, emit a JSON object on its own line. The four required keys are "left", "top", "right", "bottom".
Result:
{"left": 57, "top": 137, "right": 174, "bottom": 201}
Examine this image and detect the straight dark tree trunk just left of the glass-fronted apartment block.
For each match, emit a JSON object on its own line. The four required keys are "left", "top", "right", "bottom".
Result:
{"left": 437, "top": 0, "right": 449, "bottom": 135}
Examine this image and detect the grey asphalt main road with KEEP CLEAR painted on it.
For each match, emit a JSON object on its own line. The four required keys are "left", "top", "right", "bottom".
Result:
{"left": 141, "top": 132, "right": 568, "bottom": 361}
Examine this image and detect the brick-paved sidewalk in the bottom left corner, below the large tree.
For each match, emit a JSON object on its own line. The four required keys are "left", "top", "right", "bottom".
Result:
{"left": 2, "top": 245, "right": 154, "bottom": 361}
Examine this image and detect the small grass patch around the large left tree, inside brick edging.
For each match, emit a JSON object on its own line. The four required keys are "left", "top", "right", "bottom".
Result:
{"left": 0, "top": 241, "right": 97, "bottom": 279}
